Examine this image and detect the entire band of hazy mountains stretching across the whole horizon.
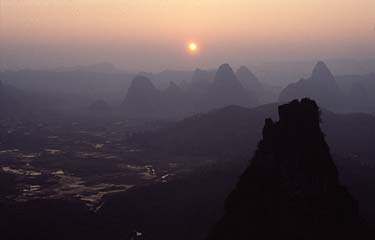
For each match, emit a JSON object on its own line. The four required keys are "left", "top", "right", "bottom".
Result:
{"left": 0, "top": 62, "right": 375, "bottom": 119}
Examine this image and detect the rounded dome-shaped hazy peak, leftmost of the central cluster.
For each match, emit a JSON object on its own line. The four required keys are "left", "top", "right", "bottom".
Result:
{"left": 123, "top": 75, "right": 161, "bottom": 118}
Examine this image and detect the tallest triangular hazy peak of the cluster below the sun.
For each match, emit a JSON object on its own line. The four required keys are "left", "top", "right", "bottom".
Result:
{"left": 200, "top": 64, "right": 256, "bottom": 111}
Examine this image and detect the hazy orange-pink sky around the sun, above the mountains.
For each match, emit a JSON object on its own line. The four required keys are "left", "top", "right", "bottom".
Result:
{"left": 0, "top": 0, "right": 375, "bottom": 71}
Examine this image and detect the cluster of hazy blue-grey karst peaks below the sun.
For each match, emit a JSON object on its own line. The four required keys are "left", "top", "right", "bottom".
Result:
{"left": 123, "top": 64, "right": 262, "bottom": 118}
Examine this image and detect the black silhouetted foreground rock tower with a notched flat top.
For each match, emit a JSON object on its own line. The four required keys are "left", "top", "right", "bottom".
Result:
{"left": 209, "top": 99, "right": 359, "bottom": 240}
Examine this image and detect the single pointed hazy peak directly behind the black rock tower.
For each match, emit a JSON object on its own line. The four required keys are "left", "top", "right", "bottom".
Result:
{"left": 279, "top": 61, "right": 345, "bottom": 111}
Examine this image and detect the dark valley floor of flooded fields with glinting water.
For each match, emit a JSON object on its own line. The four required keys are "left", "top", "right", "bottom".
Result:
{"left": 0, "top": 118, "right": 210, "bottom": 209}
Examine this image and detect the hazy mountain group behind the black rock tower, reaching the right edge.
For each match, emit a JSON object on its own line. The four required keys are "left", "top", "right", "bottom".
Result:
{"left": 279, "top": 62, "right": 375, "bottom": 113}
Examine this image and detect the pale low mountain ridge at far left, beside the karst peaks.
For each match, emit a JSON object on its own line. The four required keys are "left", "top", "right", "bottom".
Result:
{"left": 0, "top": 69, "right": 135, "bottom": 104}
